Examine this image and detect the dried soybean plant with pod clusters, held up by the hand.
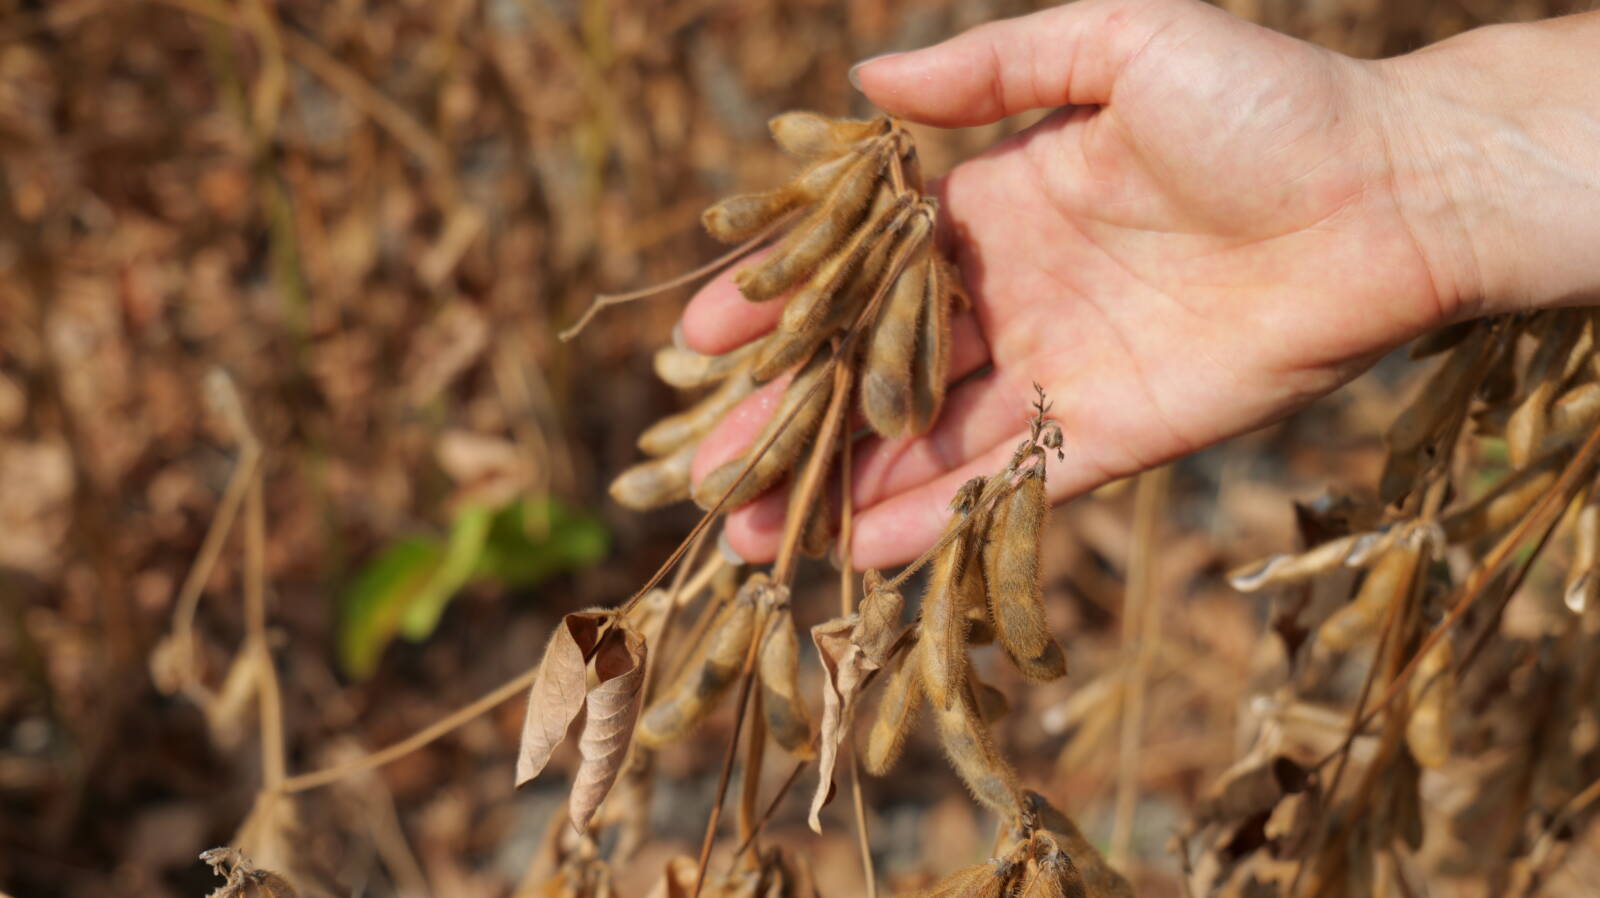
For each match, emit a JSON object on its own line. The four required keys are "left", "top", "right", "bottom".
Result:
{"left": 517, "top": 112, "right": 1126, "bottom": 896}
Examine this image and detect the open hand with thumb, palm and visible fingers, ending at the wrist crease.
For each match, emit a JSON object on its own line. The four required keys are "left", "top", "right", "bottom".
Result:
{"left": 685, "top": 0, "right": 1453, "bottom": 567}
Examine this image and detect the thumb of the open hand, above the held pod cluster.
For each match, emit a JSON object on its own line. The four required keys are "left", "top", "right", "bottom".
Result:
{"left": 850, "top": 0, "right": 1187, "bottom": 128}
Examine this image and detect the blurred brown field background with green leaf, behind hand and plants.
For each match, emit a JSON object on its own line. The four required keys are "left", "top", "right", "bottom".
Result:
{"left": 0, "top": 0, "right": 1593, "bottom": 898}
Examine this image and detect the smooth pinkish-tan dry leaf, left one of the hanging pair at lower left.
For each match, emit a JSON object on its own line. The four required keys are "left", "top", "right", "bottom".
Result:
{"left": 517, "top": 611, "right": 611, "bottom": 788}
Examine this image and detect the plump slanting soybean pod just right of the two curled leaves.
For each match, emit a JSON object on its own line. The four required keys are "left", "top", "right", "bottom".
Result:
{"left": 635, "top": 573, "right": 766, "bottom": 748}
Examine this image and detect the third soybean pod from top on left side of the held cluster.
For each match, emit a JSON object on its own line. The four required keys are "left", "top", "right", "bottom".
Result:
{"left": 734, "top": 147, "right": 885, "bottom": 303}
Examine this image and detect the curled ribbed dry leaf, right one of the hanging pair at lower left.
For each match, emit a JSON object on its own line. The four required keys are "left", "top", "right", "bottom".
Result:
{"left": 566, "top": 624, "right": 646, "bottom": 831}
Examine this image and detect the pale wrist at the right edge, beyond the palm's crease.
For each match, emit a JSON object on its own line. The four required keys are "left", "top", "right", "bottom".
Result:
{"left": 1373, "top": 14, "right": 1600, "bottom": 319}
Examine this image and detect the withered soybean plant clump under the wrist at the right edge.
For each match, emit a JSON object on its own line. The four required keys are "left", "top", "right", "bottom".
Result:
{"left": 1184, "top": 309, "right": 1600, "bottom": 896}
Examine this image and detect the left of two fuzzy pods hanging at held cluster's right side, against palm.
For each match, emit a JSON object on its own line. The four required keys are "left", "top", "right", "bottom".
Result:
{"left": 861, "top": 214, "right": 933, "bottom": 439}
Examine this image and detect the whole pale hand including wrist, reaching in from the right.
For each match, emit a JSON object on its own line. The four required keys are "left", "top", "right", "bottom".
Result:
{"left": 683, "top": 0, "right": 1600, "bottom": 568}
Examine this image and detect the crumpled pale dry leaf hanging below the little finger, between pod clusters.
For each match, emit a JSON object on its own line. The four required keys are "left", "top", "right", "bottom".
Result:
{"left": 810, "top": 576, "right": 906, "bottom": 832}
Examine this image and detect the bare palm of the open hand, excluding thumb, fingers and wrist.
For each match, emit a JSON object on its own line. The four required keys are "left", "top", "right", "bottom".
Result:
{"left": 944, "top": 12, "right": 1442, "bottom": 490}
